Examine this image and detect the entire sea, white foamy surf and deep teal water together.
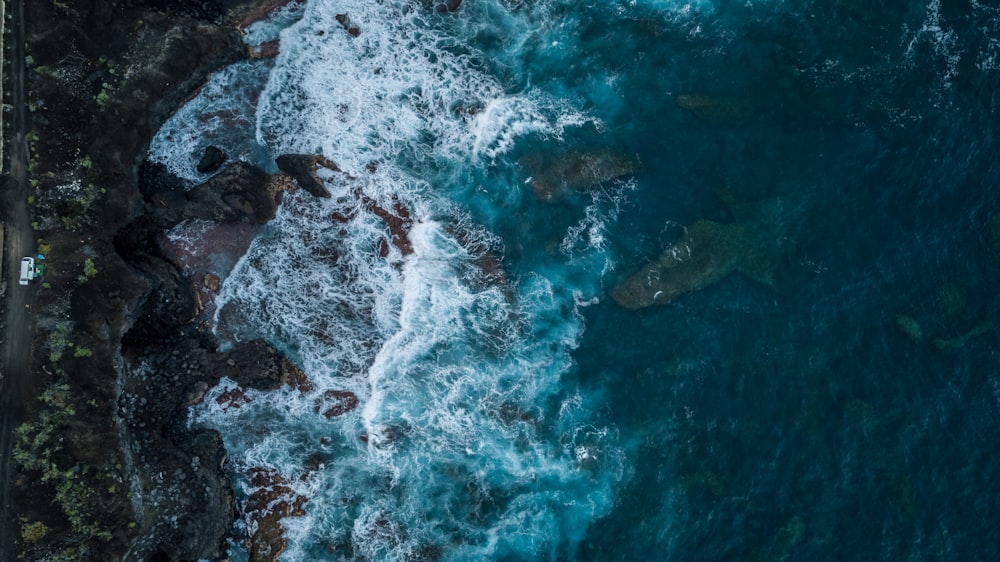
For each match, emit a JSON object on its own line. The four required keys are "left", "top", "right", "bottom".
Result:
{"left": 150, "top": 0, "right": 1000, "bottom": 561}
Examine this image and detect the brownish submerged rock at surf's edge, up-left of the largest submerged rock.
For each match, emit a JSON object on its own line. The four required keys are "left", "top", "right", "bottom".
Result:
{"left": 522, "top": 150, "right": 639, "bottom": 201}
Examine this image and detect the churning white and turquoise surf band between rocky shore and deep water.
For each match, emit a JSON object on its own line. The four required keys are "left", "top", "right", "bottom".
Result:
{"left": 150, "top": 1, "right": 634, "bottom": 560}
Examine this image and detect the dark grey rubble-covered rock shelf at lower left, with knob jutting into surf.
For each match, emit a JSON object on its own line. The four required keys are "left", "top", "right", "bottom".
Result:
{"left": 119, "top": 338, "right": 282, "bottom": 560}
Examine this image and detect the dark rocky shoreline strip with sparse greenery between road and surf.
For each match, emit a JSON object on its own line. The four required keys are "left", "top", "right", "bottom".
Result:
{"left": 15, "top": 0, "right": 296, "bottom": 560}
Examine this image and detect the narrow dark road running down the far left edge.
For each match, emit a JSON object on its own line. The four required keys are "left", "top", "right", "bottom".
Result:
{"left": 0, "top": 0, "right": 36, "bottom": 560}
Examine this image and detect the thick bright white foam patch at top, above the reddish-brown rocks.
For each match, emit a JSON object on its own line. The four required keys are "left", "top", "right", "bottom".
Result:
{"left": 258, "top": 0, "right": 586, "bottom": 174}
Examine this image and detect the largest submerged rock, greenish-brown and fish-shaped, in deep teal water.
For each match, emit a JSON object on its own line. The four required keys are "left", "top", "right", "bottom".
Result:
{"left": 611, "top": 193, "right": 801, "bottom": 309}
